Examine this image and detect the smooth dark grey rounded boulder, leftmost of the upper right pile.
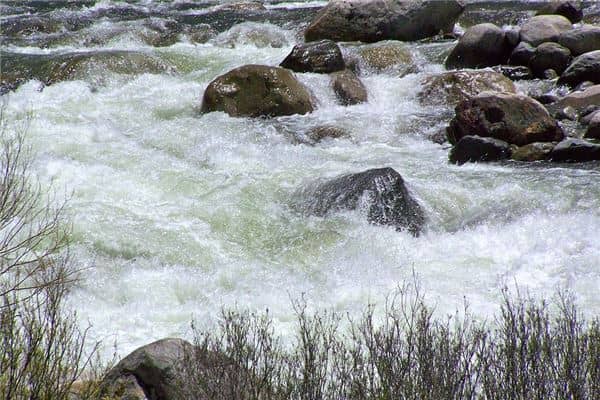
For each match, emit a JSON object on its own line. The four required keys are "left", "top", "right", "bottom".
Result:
{"left": 445, "top": 23, "right": 512, "bottom": 68}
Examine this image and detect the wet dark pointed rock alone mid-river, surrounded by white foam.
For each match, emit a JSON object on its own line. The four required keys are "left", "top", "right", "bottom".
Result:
{"left": 300, "top": 168, "right": 425, "bottom": 236}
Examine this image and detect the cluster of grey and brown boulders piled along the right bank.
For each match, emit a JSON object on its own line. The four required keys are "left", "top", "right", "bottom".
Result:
{"left": 440, "top": 1, "right": 600, "bottom": 164}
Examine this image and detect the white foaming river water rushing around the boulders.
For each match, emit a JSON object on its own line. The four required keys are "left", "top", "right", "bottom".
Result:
{"left": 1, "top": 1, "right": 600, "bottom": 353}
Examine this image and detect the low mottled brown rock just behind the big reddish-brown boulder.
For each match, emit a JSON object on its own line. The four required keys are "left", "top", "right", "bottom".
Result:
{"left": 418, "top": 71, "right": 516, "bottom": 106}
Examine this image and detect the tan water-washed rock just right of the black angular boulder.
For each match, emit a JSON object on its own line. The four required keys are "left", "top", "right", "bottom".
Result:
{"left": 358, "top": 41, "right": 416, "bottom": 77}
